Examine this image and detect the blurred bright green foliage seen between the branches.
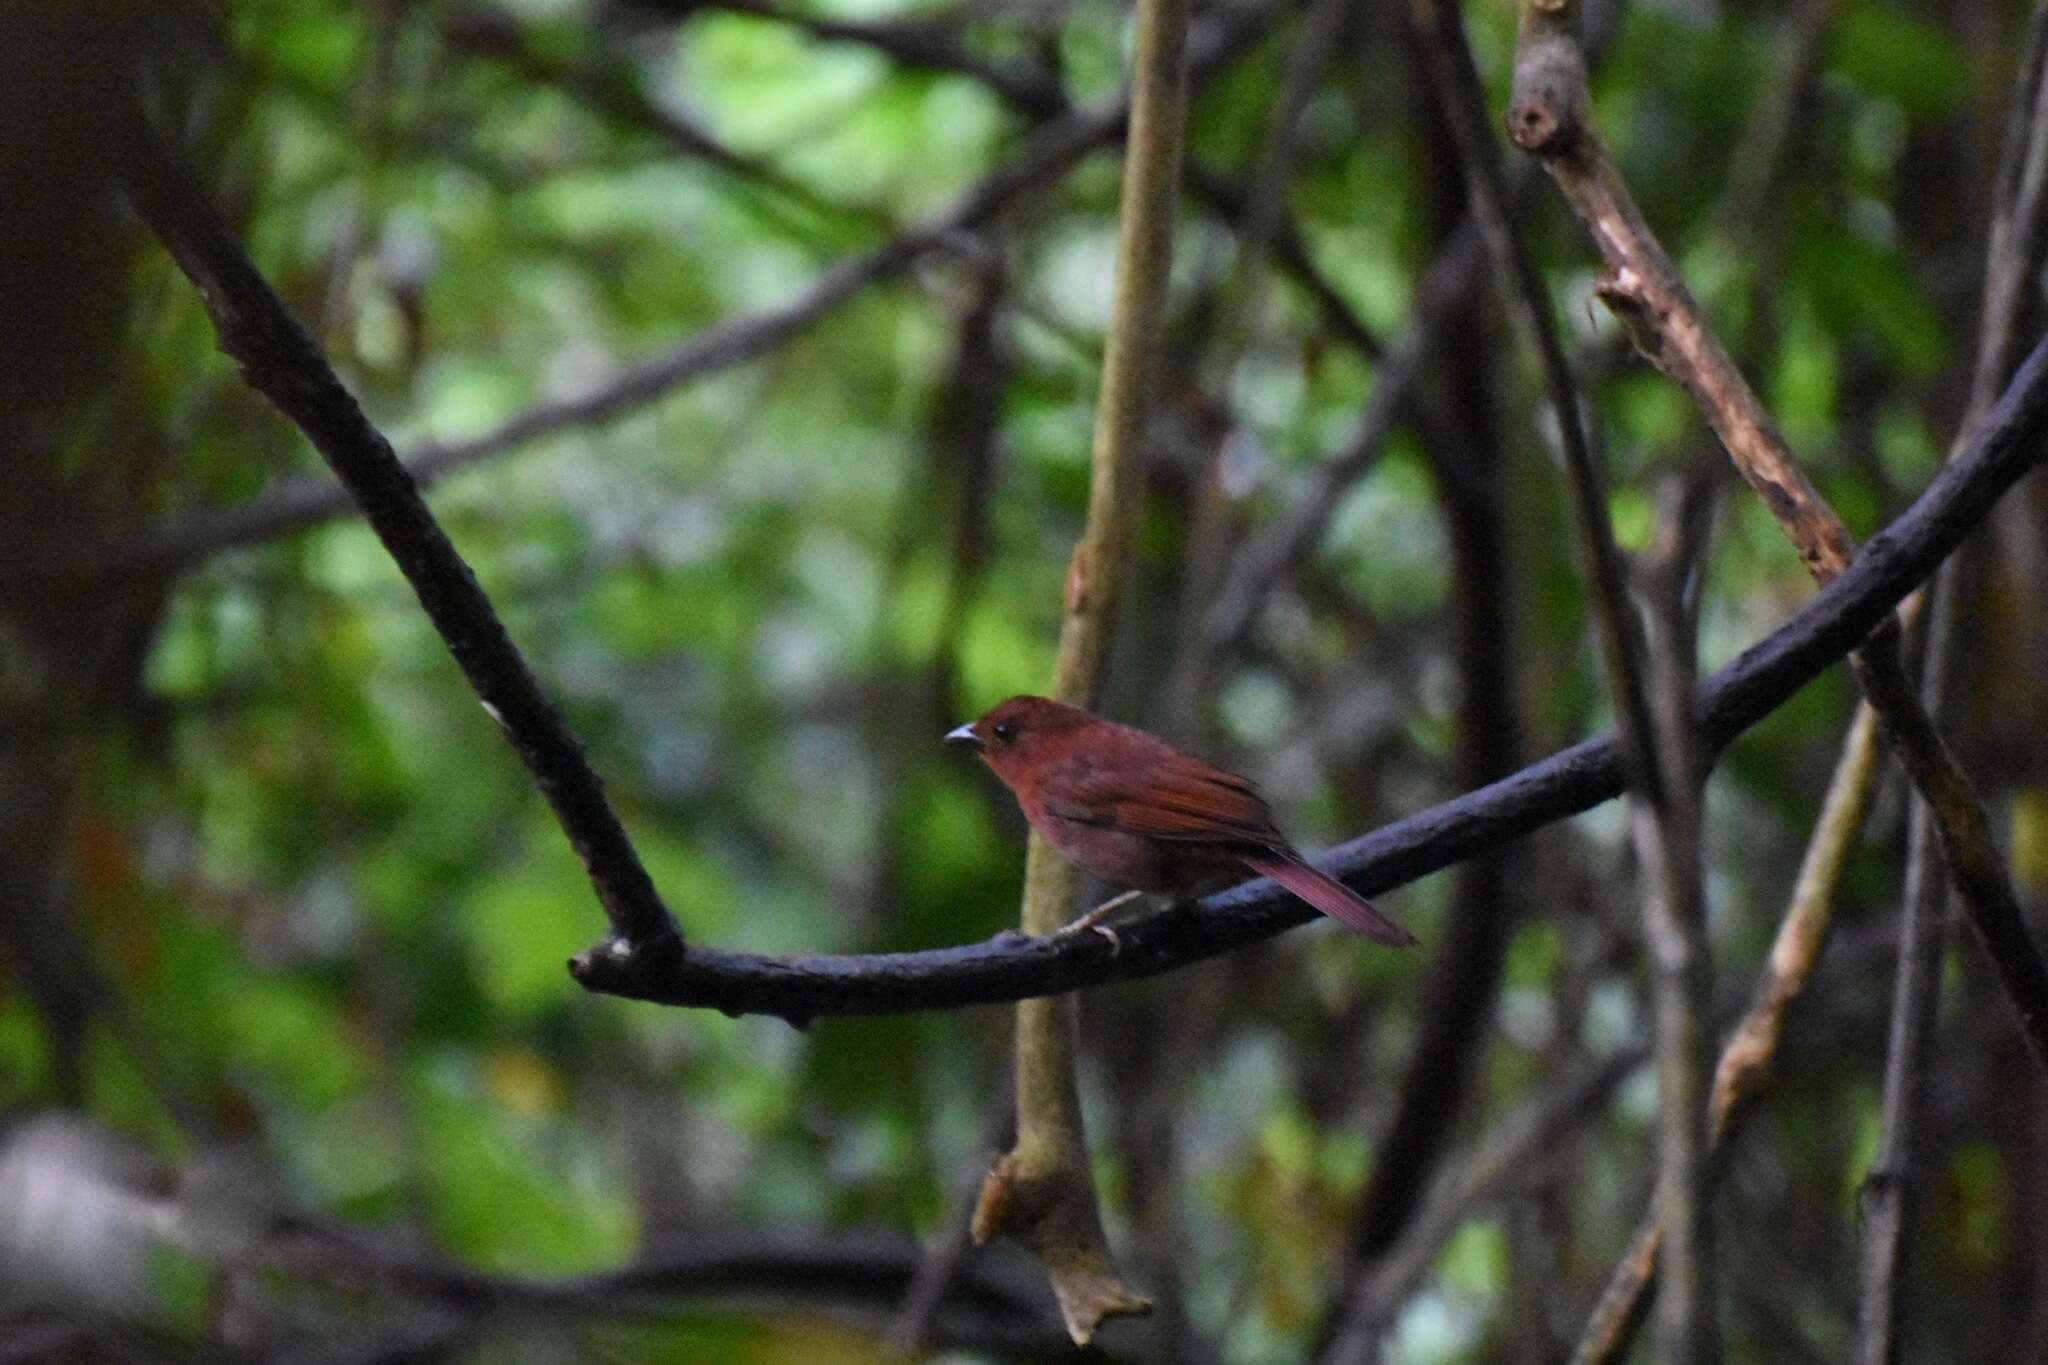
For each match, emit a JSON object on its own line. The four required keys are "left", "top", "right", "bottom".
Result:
{"left": 12, "top": 0, "right": 2048, "bottom": 1365}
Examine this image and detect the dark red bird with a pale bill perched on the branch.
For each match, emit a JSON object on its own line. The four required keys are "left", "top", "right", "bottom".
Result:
{"left": 946, "top": 696, "right": 1415, "bottom": 948}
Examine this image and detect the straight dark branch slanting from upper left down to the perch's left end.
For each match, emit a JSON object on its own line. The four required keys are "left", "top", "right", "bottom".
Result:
{"left": 121, "top": 111, "right": 682, "bottom": 964}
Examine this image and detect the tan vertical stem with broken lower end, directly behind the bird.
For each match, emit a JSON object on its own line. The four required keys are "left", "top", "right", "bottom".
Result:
{"left": 973, "top": 0, "right": 1188, "bottom": 1345}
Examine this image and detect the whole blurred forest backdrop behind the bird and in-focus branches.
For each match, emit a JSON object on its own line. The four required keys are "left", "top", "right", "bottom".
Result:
{"left": 0, "top": 0, "right": 2048, "bottom": 1365}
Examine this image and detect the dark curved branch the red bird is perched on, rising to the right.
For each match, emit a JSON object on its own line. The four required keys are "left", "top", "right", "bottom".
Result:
{"left": 571, "top": 327, "right": 2048, "bottom": 1019}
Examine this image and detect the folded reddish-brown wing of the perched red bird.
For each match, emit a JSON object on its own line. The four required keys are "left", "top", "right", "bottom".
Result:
{"left": 1047, "top": 753, "right": 1278, "bottom": 845}
